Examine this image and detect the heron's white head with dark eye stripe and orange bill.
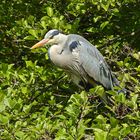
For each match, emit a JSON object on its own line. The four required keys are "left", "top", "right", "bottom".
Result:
{"left": 31, "top": 29, "right": 64, "bottom": 49}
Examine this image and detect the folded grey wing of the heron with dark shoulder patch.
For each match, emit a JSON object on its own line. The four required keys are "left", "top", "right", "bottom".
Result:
{"left": 70, "top": 37, "right": 118, "bottom": 89}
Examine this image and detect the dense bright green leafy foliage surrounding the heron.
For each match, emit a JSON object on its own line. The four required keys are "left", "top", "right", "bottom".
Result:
{"left": 0, "top": 0, "right": 140, "bottom": 140}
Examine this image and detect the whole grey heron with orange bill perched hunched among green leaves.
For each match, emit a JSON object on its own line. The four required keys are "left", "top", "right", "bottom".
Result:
{"left": 31, "top": 29, "right": 118, "bottom": 90}
